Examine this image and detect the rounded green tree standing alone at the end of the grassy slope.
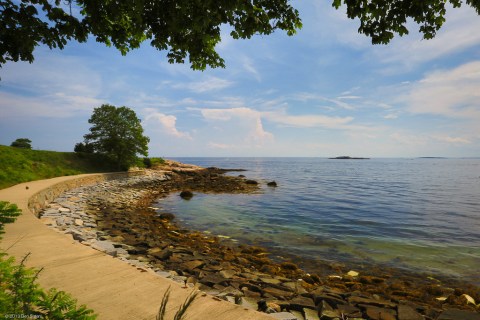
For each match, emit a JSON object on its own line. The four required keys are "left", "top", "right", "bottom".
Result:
{"left": 83, "top": 104, "right": 150, "bottom": 170}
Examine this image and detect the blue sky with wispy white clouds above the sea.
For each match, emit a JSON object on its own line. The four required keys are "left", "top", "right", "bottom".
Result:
{"left": 0, "top": 0, "right": 480, "bottom": 157}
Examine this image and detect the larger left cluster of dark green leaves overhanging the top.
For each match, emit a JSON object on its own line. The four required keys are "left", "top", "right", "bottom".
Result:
{"left": 0, "top": 0, "right": 301, "bottom": 70}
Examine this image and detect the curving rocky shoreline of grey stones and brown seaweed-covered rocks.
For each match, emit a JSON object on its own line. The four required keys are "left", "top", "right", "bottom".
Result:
{"left": 40, "top": 162, "right": 480, "bottom": 320}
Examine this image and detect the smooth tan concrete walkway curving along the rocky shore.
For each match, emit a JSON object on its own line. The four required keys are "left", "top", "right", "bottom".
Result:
{"left": 0, "top": 175, "right": 272, "bottom": 320}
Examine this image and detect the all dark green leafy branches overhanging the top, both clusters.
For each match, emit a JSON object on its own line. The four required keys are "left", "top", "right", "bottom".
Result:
{"left": 0, "top": 0, "right": 480, "bottom": 70}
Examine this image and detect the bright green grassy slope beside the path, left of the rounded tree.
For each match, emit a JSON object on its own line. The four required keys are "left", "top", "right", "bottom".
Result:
{"left": 0, "top": 145, "right": 115, "bottom": 189}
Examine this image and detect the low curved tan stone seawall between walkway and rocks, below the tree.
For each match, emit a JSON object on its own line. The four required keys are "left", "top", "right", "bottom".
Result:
{"left": 28, "top": 171, "right": 145, "bottom": 217}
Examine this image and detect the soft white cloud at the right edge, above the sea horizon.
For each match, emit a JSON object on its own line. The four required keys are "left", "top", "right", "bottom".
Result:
{"left": 404, "top": 61, "right": 480, "bottom": 120}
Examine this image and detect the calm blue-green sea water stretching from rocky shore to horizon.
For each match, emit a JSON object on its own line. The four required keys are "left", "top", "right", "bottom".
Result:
{"left": 155, "top": 158, "right": 480, "bottom": 285}
